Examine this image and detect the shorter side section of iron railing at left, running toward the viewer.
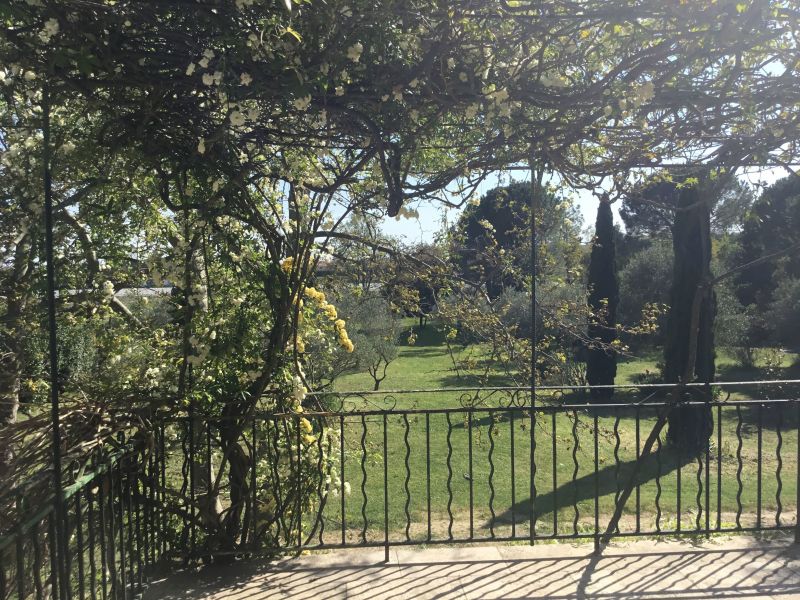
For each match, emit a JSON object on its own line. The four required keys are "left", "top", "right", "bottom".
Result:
{"left": 0, "top": 431, "right": 168, "bottom": 600}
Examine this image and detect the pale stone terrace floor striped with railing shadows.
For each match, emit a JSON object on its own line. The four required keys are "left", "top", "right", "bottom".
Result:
{"left": 145, "top": 537, "right": 800, "bottom": 600}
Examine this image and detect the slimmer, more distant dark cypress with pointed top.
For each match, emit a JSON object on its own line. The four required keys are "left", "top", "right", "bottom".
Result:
{"left": 586, "top": 201, "right": 619, "bottom": 402}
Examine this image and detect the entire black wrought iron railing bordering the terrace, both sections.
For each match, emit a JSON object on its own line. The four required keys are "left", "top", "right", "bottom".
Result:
{"left": 0, "top": 382, "right": 800, "bottom": 600}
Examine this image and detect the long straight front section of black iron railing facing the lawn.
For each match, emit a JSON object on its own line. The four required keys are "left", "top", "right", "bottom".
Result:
{"left": 164, "top": 386, "right": 800, "bottom": 556}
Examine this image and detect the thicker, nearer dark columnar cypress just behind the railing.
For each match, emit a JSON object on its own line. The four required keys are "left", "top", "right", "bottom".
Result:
{"left": 664, "top": 186, "right": 716, "bottom": 452}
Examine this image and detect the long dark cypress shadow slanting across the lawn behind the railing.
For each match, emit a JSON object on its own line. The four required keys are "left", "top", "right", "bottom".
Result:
{"left": 494, "top": 448, "right": 695, "bottom": 525}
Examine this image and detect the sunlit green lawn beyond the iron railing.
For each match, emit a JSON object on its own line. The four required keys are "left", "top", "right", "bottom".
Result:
{"left": 308, "top": 326, "right": 798, "bottom": 543}
